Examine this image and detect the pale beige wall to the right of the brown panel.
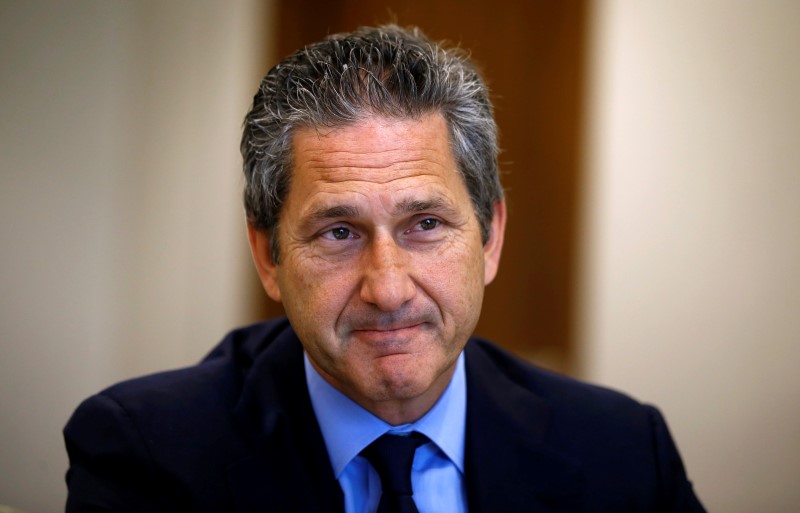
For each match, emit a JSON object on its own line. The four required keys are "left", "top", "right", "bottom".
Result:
{"left": 581, "top": 0, "right": 800, "bottom": 513}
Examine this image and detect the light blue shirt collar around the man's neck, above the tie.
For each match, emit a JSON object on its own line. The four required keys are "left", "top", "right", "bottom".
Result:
{"left": 304, "top": 351, "right": 467, "bottom": 479}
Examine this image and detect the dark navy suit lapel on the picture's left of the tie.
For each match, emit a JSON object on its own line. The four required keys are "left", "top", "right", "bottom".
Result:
{"left": 228, "top": 329, "right": 344, "bottom": 513}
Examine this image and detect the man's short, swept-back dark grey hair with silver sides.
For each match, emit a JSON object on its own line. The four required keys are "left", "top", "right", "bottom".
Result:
{"left": 241, "top": 25, "right": 503, "bottom": 263}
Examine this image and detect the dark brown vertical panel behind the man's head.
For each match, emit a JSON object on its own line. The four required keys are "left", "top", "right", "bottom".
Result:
{"left": 264, "top": 0, "right": 587, "bottom": 371}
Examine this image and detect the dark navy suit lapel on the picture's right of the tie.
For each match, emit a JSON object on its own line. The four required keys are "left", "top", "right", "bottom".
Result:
{"left": 465, "top": 340, "right": 581, "bottom": 513}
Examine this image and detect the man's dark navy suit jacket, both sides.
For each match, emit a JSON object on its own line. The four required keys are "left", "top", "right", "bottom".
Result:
{"left": 64, "top": 319, "right": 703, "bottom": 513}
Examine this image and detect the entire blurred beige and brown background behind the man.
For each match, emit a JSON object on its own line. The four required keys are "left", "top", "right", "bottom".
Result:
{"left": 0, "top": 0, "right": 800, "bottom": 513}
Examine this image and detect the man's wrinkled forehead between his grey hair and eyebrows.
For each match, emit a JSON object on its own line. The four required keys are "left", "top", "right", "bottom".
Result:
{"left": 287, "top": 114, "right": 466, "bottom": 230}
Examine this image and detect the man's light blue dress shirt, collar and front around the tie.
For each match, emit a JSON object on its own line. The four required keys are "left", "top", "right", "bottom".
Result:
{"left": 305, "top": 352, "right": 467, "bottom": 513}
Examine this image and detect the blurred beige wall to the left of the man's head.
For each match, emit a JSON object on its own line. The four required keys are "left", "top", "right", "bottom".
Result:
{"left": 0, "top": 0, "right": 268, "bottom": 513}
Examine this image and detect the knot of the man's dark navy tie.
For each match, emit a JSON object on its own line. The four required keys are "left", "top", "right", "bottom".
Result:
{"left": 361, "top": 431, "right": 428, "bottom": 496}
